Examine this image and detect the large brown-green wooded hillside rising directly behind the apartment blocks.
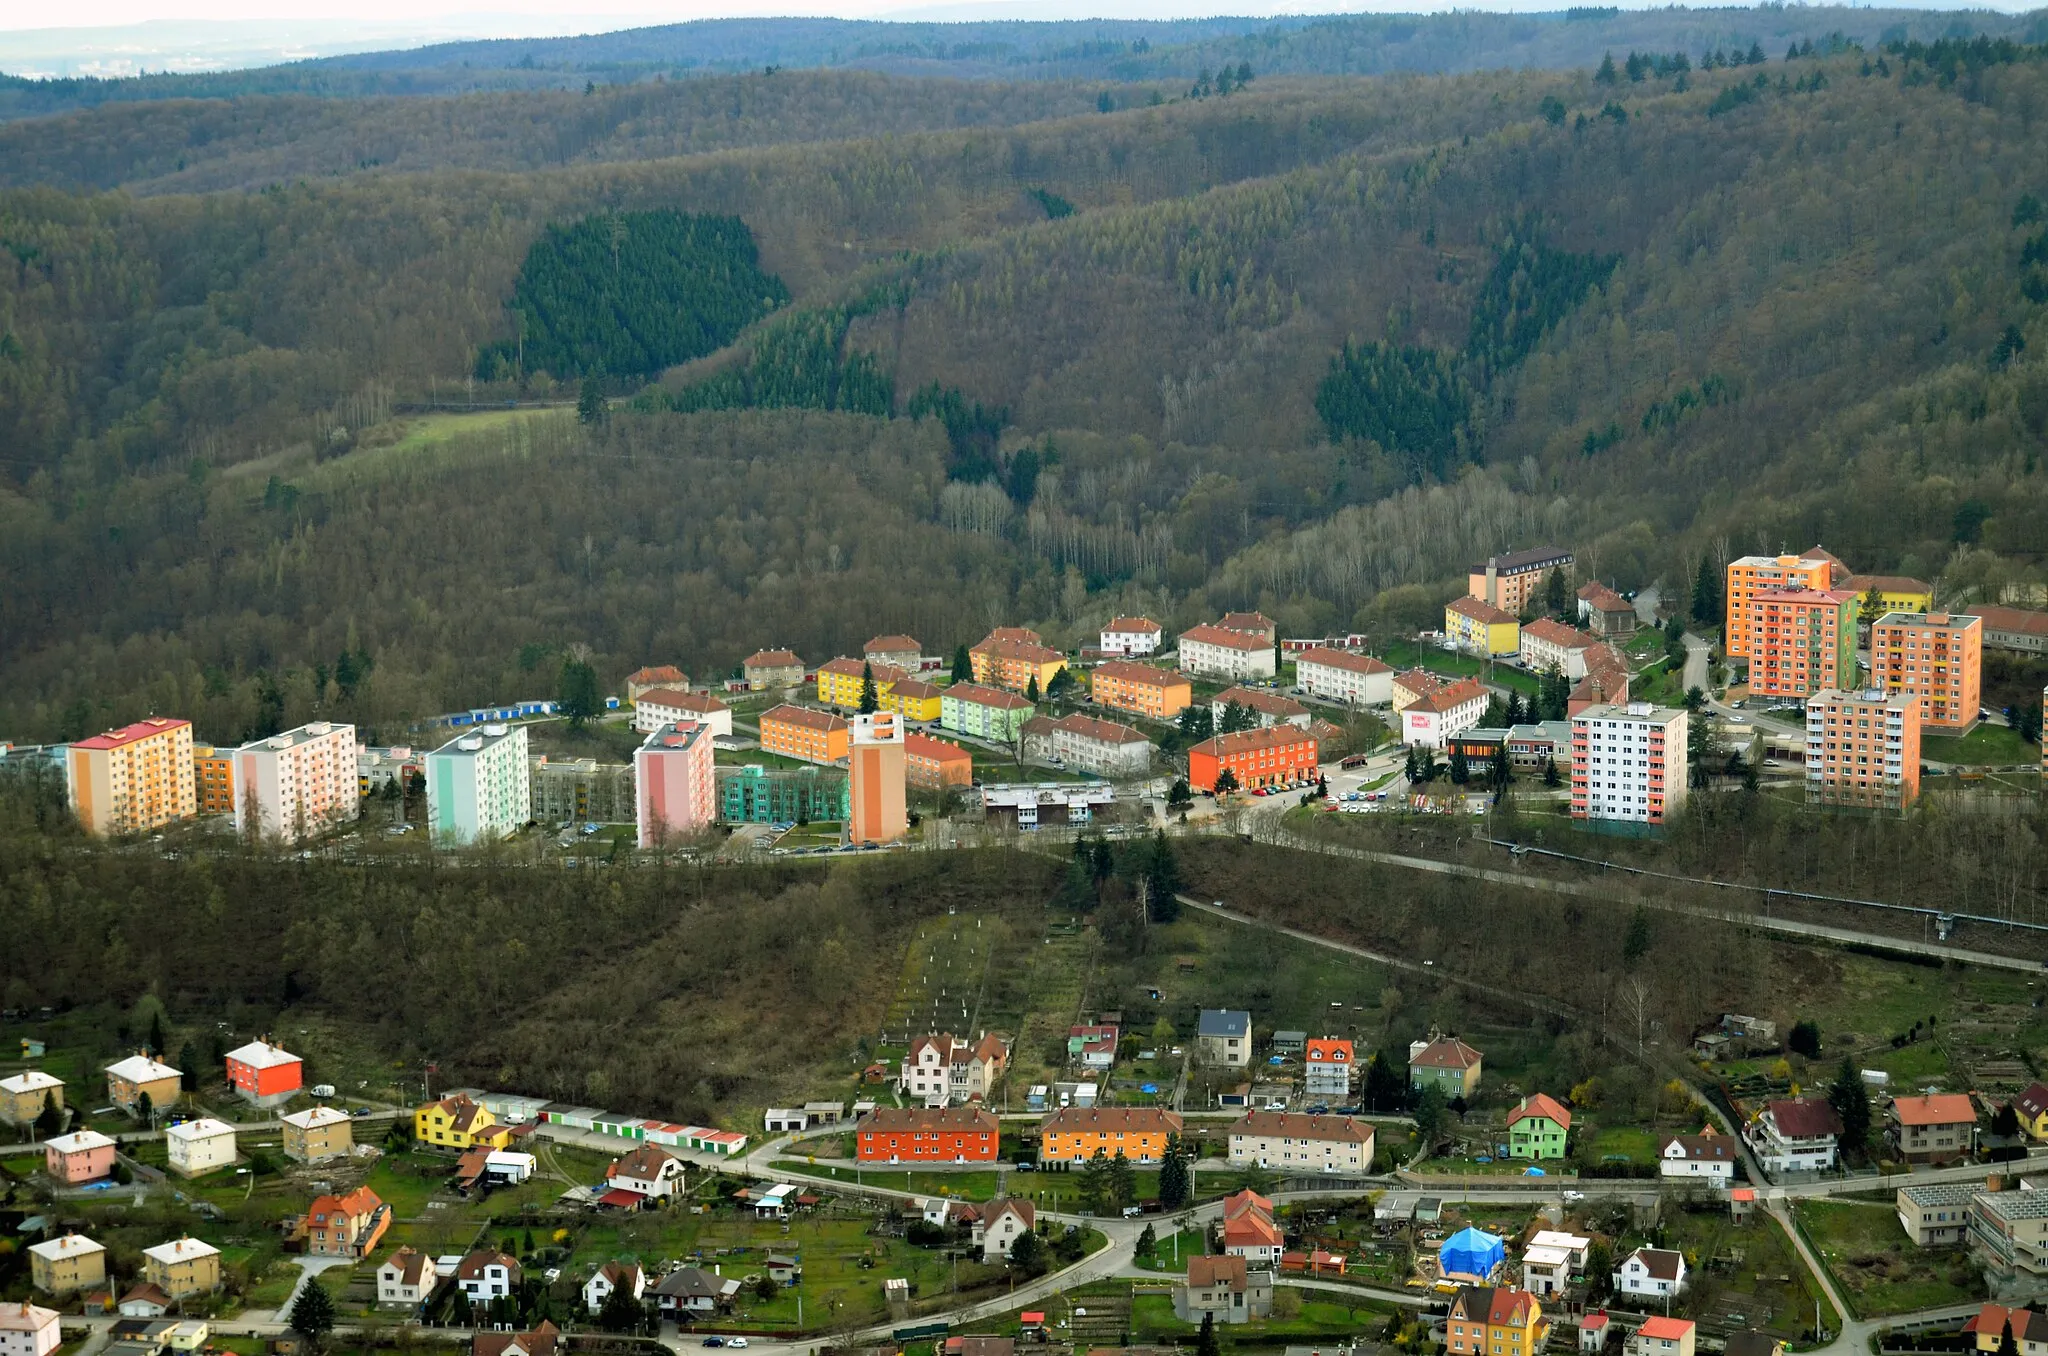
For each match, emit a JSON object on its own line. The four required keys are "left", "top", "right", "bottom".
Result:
{"left": 0, "top": 34, "right": 2048, "bottom": 737}
